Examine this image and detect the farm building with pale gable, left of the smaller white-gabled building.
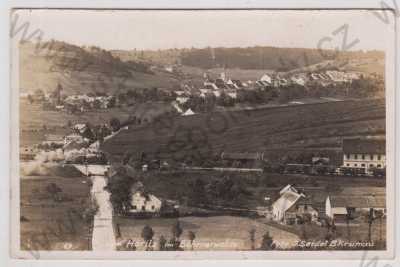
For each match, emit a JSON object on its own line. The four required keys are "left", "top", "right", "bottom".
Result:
{"left": 272, "top": 185, "right": 318, "bottom": 224}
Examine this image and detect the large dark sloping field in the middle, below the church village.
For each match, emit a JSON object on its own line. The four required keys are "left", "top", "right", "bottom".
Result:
{"left": 103, "top": 100, "right": 385, "bottom": 164}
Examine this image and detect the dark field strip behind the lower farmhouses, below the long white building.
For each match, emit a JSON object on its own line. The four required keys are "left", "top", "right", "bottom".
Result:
{"left": 122, "top": 171, "right": 386, "bottom": 213}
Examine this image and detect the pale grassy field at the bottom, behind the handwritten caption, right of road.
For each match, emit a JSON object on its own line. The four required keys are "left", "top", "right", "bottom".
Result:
{"left": 115, "top": 216, "right": 298, "bottom": 250}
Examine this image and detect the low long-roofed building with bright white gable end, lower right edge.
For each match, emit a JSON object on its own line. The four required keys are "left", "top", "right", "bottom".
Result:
{"left": 325, "top": 187, "right": 386, "bottom": 223}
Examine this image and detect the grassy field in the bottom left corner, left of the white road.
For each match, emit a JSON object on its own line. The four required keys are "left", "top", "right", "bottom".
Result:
{"left": 20, "top": 176, "right": 93, "bottom": 250}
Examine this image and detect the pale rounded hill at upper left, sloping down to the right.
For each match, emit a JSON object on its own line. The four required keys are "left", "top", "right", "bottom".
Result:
{"left": 19, "top": 41, "right": 179, "bottom": 94}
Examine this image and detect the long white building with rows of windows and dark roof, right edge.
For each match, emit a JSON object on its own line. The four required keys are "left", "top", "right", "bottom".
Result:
{"left": 343, "top": 139, "right": 386, "bottom": 172}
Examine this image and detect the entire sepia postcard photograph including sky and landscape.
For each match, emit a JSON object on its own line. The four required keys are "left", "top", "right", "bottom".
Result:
{"left": 10, "top": 9, "right": 394, "bottom": 258}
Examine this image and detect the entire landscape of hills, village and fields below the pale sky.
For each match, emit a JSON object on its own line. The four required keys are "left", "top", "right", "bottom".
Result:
{"left": 19, "top": 27, "right": 388, "bottom": 251}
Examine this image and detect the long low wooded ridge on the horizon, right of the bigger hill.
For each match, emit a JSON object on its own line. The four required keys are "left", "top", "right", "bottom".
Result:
{"left": 111, "top": 46, "right": 384, "bottom": 72}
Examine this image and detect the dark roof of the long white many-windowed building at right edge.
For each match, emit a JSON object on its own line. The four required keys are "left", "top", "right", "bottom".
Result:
{"left": 343, "top": 139, "right": 386, "bottom": 154}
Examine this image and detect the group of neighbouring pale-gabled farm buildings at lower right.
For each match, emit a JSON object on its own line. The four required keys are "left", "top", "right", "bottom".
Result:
{"left": 265, "top": 185, "right": 386, "bottom": 225}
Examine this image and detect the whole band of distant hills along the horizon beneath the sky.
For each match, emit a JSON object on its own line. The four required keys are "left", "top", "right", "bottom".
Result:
{"left": 19, "top": 41, "right": 384, "bottom": 94}
